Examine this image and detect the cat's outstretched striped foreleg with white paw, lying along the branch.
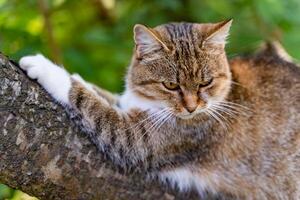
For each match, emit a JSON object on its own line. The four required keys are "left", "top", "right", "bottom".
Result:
{"left": 20, "top": 55, "right": 191, "bottom": 173}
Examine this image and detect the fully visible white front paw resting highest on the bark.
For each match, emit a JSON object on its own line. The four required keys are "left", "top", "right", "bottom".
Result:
{"left": 19, "top": 54, "right": 71, "bottom": 104}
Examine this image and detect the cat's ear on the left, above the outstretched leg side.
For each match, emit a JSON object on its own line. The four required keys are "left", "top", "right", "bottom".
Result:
{"left": 133, "top": 24, "right": 169, "bottom": 58}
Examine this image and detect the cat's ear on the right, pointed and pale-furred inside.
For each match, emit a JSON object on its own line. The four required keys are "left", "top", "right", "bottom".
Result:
{"left": 202, "top": 19, "right": 232, "bottom": 47}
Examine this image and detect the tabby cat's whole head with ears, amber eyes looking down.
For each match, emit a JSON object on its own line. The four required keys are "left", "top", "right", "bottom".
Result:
{"left": 128, "top": 21, "right": 231, "bottom": 119}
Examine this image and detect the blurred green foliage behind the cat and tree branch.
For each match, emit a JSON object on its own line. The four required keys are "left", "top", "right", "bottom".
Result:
{"left": 0, "top": 0, "right": 300, "bottom": 200}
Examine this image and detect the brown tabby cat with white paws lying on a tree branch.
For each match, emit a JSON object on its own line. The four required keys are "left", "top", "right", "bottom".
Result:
{"left": 20, "top": 20, "right": 300, "bottom": 200}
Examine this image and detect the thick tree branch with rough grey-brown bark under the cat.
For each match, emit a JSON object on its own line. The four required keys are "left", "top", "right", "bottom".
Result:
{"left": 0, "top": 54, "right": 200, "bottom": 200}
